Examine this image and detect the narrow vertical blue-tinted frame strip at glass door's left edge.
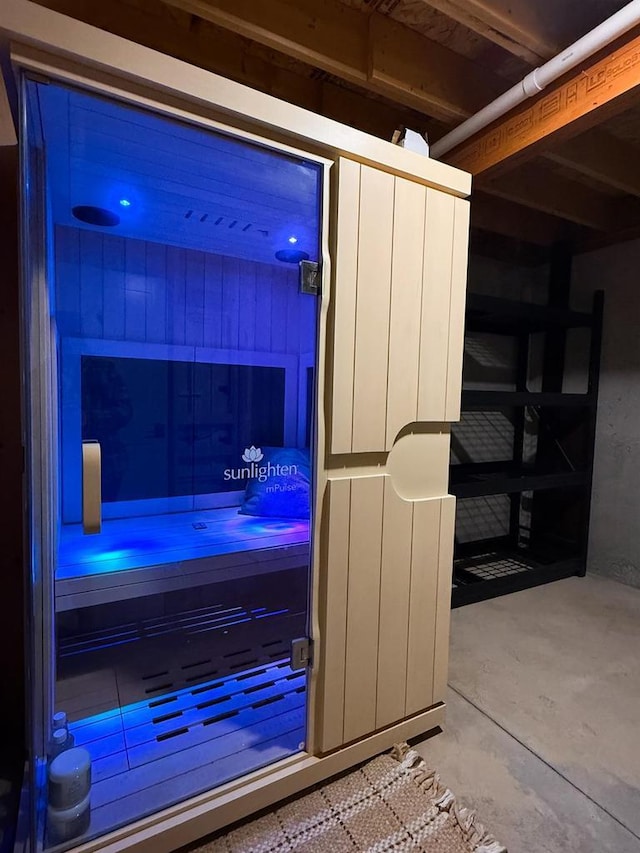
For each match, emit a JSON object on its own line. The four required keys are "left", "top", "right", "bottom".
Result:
{"left": 19, "top": 73, "right": 57, "bottom": 836}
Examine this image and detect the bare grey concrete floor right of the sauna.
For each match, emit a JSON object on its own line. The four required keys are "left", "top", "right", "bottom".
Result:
{"left": 419, "top": 576, "right": 640, "bottom": 853}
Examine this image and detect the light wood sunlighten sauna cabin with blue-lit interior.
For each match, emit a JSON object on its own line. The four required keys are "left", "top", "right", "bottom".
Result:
{"left": 0, "top": 0, "right": 469, "bottom": 851}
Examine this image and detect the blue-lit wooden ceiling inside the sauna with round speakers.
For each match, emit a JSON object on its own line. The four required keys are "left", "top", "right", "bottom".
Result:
{"left": 38, "top": 86, "right": 318, "bottom": 263}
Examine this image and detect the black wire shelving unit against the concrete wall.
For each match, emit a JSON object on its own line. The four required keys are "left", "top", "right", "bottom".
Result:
{"left": 449, "top": 246, "right": 604, "bottom": 607}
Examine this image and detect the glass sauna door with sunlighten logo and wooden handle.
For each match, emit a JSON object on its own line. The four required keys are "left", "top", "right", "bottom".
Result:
{"left": 24, "top": 76, "right": 322, "bottom": 847}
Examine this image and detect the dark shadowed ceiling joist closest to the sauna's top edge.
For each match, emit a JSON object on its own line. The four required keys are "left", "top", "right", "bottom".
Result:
{"left": 30, "top": 0, "right": 434, "bottom": 139}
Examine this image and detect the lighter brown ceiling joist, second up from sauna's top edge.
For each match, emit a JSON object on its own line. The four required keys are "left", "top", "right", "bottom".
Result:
{"left": 163, "top": 0, "right": 506, "bottom": 123}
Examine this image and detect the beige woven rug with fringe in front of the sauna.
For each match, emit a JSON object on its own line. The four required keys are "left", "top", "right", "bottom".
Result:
{"left": 193, "top": 744, "right": 506, "bottom": 853}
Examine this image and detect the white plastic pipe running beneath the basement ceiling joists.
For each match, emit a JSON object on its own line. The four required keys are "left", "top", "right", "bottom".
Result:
{"left": 430, "top": 0, "right": 640, "bottom": 158}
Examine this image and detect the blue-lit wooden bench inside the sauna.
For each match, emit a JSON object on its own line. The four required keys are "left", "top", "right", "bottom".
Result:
{"left": 55, "top": 506, "right": 309, "bottom": 611}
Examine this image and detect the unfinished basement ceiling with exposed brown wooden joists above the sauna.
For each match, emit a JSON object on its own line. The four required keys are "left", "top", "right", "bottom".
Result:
{"left": 32, "top": 0, "right": 640, "bottom": 254}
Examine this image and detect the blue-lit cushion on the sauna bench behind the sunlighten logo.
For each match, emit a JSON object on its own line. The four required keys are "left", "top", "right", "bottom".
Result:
{"left": 238, "top": 447, "right": 311, "bottom": 518}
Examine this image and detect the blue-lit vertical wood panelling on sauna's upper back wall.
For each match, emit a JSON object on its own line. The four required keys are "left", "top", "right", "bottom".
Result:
{"left": 55, "top": 226, "right": 316, "bottom": 355}
